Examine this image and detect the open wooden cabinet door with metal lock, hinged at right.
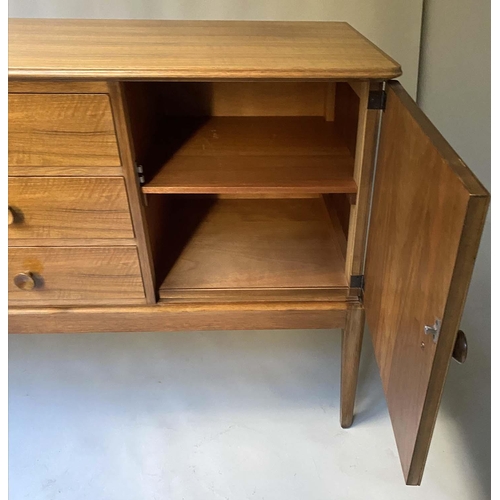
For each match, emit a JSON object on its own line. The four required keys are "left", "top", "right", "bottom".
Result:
{"left": 364, "top": 82, "right": 489, "bottom": 484}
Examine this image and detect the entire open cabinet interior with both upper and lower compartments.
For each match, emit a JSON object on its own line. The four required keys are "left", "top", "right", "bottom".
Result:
{"left": 125, "top": 82, "right": 359, "bottom": 302}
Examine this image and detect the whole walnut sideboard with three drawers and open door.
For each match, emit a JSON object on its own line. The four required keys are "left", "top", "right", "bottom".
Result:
{"left": 9, "top": 19, "right": 489, "bottom": 484}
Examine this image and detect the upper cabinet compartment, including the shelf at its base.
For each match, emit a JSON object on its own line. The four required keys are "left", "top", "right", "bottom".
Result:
{"left": 126, "top": 82, "right": 359, "bottom": 194}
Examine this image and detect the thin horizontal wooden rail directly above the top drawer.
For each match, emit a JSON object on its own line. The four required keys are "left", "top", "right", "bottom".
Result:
{"left": 9, "top": 80, "right": 108, "bottom": 94}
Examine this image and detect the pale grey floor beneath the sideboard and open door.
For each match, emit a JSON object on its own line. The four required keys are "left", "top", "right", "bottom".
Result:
{"left": 9, "top": 331, "right": 490, "bottom": 500}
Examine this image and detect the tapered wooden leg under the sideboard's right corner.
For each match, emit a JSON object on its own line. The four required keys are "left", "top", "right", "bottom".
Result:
{"left": 340, "top": 304, "right": 365, "bottom": 429}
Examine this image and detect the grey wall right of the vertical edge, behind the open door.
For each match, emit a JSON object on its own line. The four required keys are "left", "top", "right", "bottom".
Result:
{"left": 419, "top": 0, "right": 491, "bottom": 490}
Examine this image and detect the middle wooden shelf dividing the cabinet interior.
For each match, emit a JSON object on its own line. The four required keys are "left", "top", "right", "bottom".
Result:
{"left": 142, "top": 117, "right": 357, "bottom": 194}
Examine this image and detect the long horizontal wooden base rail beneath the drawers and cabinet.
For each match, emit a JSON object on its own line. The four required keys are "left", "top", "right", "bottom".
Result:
{"left": 9, "top": 300, "right": 346, "bottom": 333}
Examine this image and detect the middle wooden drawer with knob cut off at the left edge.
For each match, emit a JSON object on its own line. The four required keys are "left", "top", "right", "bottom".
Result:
{"left": 9, "top": 177, "right": 134, "bottom": 244}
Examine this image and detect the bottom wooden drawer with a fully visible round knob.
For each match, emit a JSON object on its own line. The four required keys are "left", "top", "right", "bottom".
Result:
{"left": 8, "top": 247, "right": 144, "bottom": 306}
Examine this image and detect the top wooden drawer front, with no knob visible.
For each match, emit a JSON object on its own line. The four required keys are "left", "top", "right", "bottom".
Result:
{"left": 9, "top": 94, "right": 120, "bottom": 167}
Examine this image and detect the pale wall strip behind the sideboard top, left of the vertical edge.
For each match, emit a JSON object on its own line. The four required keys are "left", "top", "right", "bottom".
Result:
{"left": 9, "top": 0, "right": 422, "bottom": 96}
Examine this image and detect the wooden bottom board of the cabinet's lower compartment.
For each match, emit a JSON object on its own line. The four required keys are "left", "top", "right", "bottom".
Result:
{"left": 160, "top": 196, "right": 347, "bottom": 301}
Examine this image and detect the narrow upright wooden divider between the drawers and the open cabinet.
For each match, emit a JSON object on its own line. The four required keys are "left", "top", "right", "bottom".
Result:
{"left": 109, "top": 82, "right": 156, "bottom": 304}
